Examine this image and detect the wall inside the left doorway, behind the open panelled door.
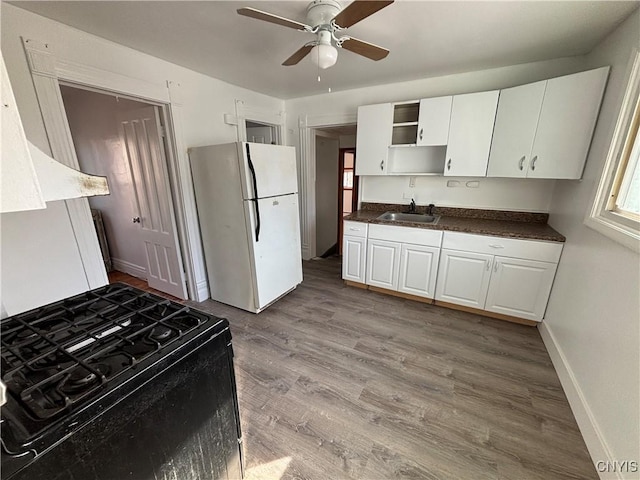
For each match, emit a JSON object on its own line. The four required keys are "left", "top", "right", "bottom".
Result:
{"left": 61, "top": 86, "right": 147, "bottom": 278}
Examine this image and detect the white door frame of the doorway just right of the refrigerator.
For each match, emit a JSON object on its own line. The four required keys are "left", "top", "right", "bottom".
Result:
{"left": 298, "top": 113, "right": 360, "bottom": 260}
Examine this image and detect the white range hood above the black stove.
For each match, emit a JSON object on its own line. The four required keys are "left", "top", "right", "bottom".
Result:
{"left": 0, "top": 53, "right": 109, "bottom": 213}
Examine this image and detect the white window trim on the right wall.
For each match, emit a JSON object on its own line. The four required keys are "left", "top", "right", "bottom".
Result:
{"left": 584, "top": 49, "right": 640, "bottom": 253}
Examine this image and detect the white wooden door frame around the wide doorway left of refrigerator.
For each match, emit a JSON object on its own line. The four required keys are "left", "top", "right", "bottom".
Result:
{"left": 22, "top": 38, "right": 209, "bottom": 302}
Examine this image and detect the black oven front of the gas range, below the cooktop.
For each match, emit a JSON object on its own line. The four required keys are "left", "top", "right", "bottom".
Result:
{"left": 2, "top": 329, "right": 242, "bottom": 480}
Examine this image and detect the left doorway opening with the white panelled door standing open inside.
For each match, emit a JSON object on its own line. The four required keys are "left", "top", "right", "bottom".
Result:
{"left": 60, "top": 83, "right": 187, "bottom": 299}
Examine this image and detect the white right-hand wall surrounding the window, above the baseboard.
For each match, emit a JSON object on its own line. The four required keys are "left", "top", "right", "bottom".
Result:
{"left": 541, "top": 10, "right": 640, "bottom": 479}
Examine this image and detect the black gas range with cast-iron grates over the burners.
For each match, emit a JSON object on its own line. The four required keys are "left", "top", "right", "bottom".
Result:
{"left": 0, "top": 284, "right": 242, "bottom": 480}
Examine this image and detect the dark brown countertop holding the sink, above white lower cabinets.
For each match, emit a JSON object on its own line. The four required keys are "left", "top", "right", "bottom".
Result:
{"left": 344, "top": 204, "right": 565, "bottom": 242}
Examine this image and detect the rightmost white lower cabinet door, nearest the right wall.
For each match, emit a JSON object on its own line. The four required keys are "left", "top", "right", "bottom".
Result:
{"left": 485, "top": 257, "right": 557, "bottom": 321}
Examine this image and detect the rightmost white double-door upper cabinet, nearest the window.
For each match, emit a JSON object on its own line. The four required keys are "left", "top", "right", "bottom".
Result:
{"left": 487, "top": 67, "right": 609, "bottom": 179}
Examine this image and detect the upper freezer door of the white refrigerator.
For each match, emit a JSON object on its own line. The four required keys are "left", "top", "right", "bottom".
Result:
{"left": 238, "top": 142, "right": 298, "bottom": 200}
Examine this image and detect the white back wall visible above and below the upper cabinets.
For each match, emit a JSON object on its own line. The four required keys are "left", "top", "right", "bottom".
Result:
{"left": 286, "top": 57, "right": 587, "bottom": 212}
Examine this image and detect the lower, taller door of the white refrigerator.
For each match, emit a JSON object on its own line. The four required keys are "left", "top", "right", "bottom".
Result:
{"left": 244, "top": 194, "right": 302, "bottom": 311}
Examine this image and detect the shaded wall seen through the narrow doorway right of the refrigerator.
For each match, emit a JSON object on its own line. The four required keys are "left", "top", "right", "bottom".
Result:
{"left": 316, "top": 136, "right": 339, "bottom": 255}
